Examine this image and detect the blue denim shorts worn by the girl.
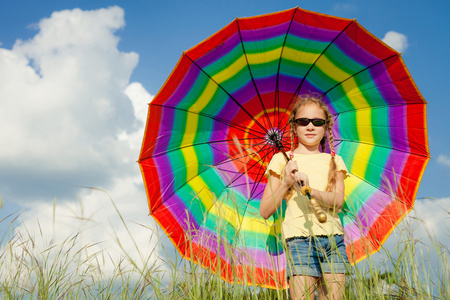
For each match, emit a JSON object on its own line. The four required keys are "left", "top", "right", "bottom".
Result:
{"left": 286, "top": 235, "right": 348, "bottom": 278}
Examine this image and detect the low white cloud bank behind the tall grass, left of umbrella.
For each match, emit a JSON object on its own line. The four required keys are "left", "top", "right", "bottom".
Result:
{"left": 0, "top": 176, "right": 173, "bottom": 286}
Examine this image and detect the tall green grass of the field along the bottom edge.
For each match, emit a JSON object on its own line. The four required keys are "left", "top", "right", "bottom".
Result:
{"left": 0, "top": 196, "right": 450, "bottom": 299}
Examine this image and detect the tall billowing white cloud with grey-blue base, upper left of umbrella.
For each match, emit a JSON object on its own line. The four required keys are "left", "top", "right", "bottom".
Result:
{"left": 0, "top": 7, "right": 142, "bottom": 201}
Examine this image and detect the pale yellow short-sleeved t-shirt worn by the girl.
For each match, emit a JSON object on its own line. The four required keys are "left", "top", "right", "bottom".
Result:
{"left": 266, "top": 153, "right": 348, "bottom": 238}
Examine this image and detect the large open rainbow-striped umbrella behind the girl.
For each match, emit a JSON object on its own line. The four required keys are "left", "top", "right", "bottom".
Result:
{"left": 139, "top": 8, "right": 429, "bottom": 288}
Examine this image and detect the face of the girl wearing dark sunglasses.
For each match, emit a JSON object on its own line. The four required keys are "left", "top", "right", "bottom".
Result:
{"left": 295, "top": 103, "right": 326, "bottom": 151}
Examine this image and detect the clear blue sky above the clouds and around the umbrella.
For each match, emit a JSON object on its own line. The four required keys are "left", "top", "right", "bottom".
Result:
{"left": 0, "top": 0, "right": 450, "bottom": 200}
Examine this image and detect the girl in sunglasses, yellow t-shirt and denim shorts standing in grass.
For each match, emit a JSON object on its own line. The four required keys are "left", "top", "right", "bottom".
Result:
{"left": 260, "top": 96, "right": 348, "bottom": 299}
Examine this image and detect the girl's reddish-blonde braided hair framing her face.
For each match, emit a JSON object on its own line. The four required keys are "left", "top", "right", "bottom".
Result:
{"left": 288, "top": 95, "right": 336, "bottom": 192}
